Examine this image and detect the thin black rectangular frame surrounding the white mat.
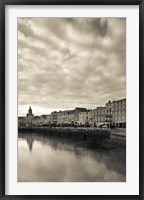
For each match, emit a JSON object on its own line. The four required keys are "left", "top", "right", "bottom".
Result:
{"left": 0, "top": 0, "right": 144, "bottom": 200}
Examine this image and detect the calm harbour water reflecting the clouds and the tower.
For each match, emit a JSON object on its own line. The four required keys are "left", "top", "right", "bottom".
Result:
{"left": 18, "top": 133, "right": 126, "bottom": 182}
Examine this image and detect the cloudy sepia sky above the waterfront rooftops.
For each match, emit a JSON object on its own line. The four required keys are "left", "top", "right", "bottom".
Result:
{"left": 18, "top": 18, "right": 126, "bottom": 116}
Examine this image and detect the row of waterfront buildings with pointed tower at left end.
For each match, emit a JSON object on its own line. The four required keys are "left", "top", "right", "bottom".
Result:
{"left": 18, "top": 99, "right": 126, "bottom": 128}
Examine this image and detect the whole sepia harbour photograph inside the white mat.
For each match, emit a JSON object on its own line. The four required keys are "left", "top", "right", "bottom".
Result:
{"left": 17, "top": 17, "right": 126, "bottom": 182}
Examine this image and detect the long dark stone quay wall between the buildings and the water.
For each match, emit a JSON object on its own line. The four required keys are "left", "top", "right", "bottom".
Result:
{"left": 18, "top": 127, "right": 126, "bottom": 148}
